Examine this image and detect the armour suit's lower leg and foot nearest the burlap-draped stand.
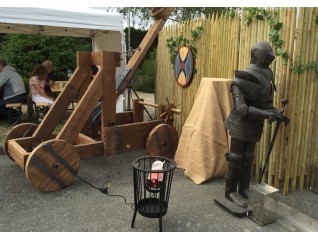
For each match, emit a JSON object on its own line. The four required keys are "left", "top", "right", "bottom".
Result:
{"left": 225, "top": 152, "right": 247, "bottom": 208}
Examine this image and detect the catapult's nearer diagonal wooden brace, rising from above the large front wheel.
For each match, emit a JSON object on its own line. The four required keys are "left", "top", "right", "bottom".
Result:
{"left": 56, "top": 72, "right": 102, "bottom": 143}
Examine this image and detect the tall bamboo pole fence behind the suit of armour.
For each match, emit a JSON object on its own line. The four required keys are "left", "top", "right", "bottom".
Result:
{"left": 155, "top": 8, "right": 318, "bottom": 194}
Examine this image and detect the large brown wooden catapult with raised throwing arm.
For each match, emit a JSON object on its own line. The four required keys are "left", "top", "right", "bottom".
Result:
{"left": 4, "top": 8, "right": 180, "bottom": 192}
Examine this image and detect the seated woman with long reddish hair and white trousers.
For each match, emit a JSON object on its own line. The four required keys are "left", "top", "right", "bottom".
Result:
{"left": 29, "top": 65, "right": 54, "bottom": 105}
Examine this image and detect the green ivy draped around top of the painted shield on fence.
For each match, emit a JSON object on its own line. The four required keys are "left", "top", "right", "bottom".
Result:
{"left": 167, "top": 26, "right": 204, "bottom": 64}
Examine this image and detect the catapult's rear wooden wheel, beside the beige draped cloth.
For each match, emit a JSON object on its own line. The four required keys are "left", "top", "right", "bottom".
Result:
{"left": 146, "top": 124, "right": 179, "bottom": 158}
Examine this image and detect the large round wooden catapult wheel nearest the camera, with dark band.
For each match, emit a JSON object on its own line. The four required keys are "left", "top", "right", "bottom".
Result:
{"left": 25, "top": 139, "right": 80, "bottom": 192}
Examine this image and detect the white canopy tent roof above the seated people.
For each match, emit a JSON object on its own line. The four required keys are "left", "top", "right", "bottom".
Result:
{"left": 0, "top": 7, "right": 126, "bottom": 111}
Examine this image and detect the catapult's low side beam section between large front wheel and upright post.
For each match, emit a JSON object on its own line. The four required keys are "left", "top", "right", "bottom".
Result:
{"left": 74, "top": 141, "right": 104, "bottom": 160}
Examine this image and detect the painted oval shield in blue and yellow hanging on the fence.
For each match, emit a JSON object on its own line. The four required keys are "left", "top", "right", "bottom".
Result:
{"left": 174, "top": 46, "right": 194, "bottom": 87}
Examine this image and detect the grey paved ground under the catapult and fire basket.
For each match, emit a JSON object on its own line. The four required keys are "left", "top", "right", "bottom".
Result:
{"left": 0, "top": 91, "right": 318, "bottom": 232}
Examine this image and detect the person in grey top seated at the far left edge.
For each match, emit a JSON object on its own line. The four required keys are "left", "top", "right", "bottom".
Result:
{"left": 0, "top": 59, "right": 26, "bottom": 124}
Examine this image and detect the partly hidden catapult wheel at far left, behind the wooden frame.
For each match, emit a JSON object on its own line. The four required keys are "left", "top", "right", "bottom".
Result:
{"left": 3, "top": 123, "right": 38, "bottom": 160}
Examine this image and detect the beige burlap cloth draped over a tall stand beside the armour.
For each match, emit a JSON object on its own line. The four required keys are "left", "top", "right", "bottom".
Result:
{"left": 175, "top": 78, "right": 232, "bottom": 184}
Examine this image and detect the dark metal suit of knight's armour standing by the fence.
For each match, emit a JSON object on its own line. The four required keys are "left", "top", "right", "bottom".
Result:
{"left": 224, "top": 42, "right": 279, "bottom": 207}
